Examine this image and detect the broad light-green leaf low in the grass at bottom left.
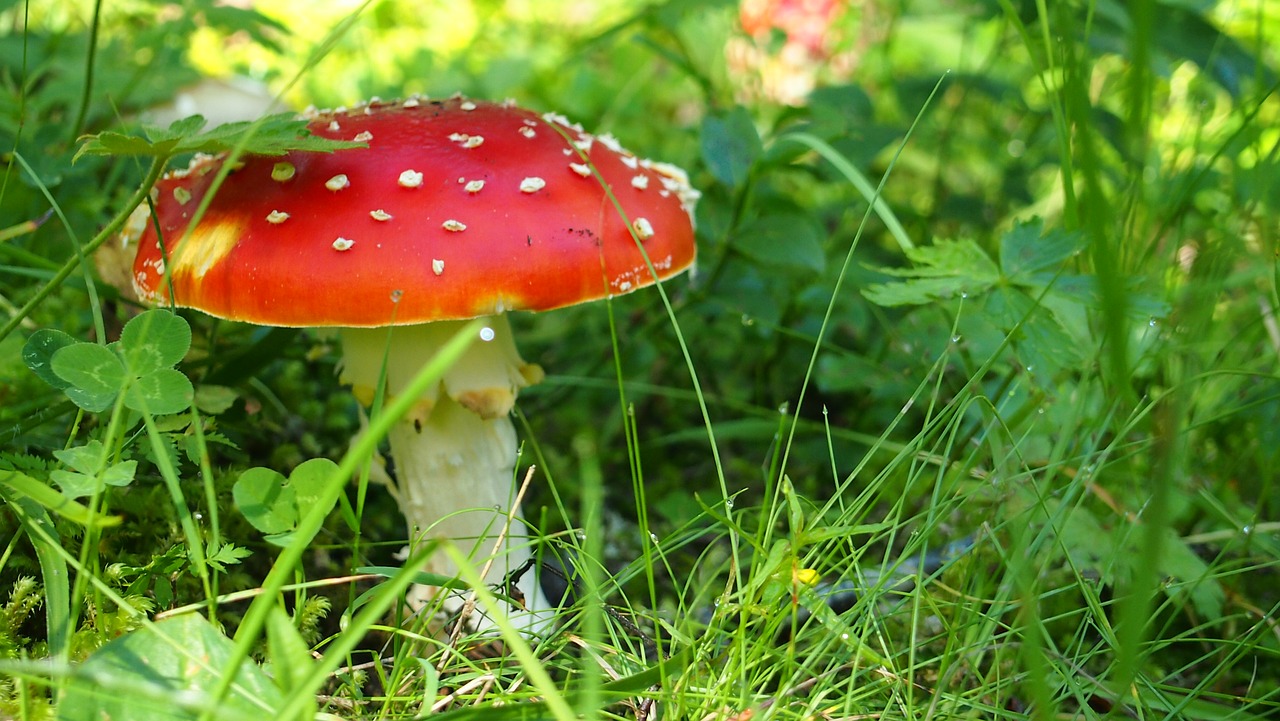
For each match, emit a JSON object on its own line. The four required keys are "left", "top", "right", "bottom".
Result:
{"left": 58, "top": 613, "right": 280, "bottom": 721}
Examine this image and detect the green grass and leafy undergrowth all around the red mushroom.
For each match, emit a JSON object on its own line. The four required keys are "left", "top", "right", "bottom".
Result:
{"left": 0, "top": 0, "right": 1280, "bottom": 720}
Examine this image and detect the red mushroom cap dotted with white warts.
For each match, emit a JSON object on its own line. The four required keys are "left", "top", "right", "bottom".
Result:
{"left": 133, "top": 97, "right": 698, "bottom": 327}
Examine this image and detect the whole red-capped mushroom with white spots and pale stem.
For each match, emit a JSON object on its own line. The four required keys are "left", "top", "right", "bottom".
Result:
{"left": 123, "top": 97, "right": 698, "bottom": 632}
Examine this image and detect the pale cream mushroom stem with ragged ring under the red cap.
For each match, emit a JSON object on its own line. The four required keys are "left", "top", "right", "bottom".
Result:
{"left": 340, "top": 315, "right": 550, "bottom": 629}
